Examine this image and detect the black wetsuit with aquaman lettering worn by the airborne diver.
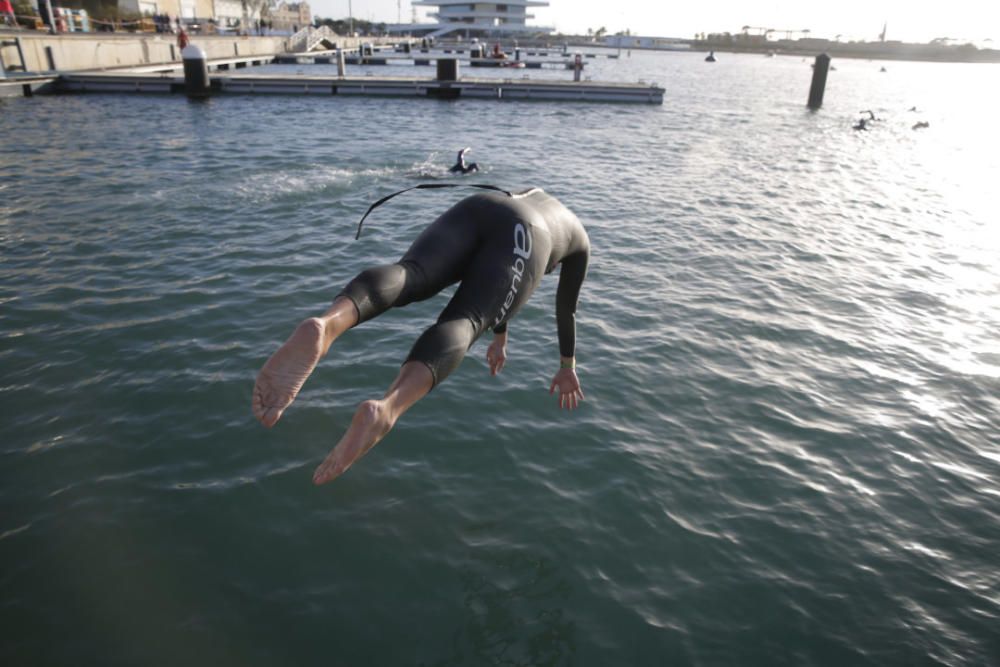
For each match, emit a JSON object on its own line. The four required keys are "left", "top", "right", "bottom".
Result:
{"left": 341, "top": 188, "right": 590, "bottom": 384}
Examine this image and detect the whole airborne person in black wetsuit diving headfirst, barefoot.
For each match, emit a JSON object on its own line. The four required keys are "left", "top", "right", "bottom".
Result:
{"left": 252, "top": 188, "right": 590, "bottom": 484}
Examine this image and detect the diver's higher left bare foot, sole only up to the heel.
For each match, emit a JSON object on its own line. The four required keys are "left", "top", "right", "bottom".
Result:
{"left": 253, "top": 317, "right": 328, "bottom": 428}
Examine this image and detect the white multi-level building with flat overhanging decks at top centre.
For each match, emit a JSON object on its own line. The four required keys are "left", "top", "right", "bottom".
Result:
{"left": 389, "top": 0, "right": 553, "bottom": 37}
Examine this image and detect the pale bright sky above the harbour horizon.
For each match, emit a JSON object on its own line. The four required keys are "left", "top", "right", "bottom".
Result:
{"left": 309, "top": 0, "right": 1000, "bottom": 44}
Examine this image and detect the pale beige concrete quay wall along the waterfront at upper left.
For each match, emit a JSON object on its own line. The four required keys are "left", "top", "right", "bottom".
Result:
{"left": 0, "top": 32, "right": 396, "bottom": 74}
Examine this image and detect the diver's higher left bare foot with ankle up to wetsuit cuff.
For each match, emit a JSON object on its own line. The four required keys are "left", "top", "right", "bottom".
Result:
{"left": 253, "top": 296, "right": 358, "bottom": 428}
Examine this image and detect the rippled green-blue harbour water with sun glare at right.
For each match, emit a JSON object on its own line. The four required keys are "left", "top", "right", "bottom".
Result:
{"left": 0, "top": 53, "right": 1000, "bottom": 666}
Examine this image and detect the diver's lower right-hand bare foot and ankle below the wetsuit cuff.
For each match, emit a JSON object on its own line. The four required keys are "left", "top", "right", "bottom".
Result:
{"left": 313, "top": 361, "right": 434, "bottom": 484}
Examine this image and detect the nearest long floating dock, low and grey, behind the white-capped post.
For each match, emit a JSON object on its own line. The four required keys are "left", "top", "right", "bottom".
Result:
{"left": 54, "top": 72, "right": 664, "bottom": 104}
